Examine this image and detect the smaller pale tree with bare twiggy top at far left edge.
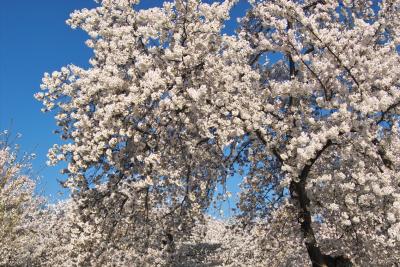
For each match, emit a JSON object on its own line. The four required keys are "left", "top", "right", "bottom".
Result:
{"left": 0, "top": 131, "right": 42, "bottom": 266}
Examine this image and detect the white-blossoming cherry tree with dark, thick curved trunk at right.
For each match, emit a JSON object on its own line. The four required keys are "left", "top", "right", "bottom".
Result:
{"left": 234, "top": 1, "right": 400, "bottom": 266}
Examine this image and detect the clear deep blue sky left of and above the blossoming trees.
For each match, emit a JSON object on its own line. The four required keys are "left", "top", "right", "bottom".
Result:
{"left": 0, "top": 0, "right": 248, "bottom": 203}
